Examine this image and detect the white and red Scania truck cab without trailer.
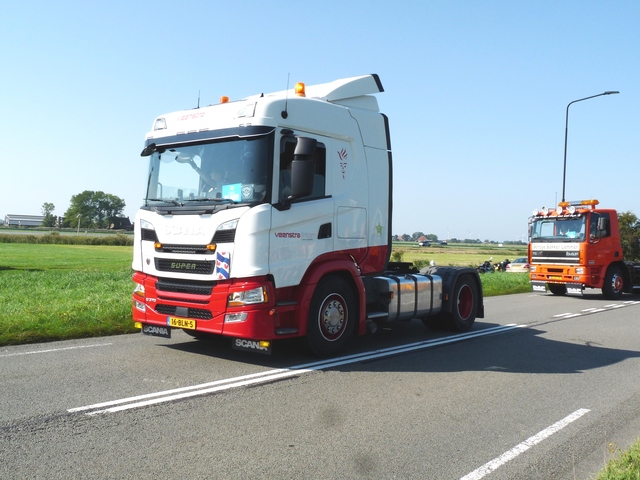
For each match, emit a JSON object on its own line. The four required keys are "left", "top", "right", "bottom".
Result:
{"left": 133, "top": 75, "right": 484, "bottom": 356}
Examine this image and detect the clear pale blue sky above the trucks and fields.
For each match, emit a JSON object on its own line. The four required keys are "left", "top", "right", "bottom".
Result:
{"left": 0, "top": 0, "right": 640, "bottom": 241}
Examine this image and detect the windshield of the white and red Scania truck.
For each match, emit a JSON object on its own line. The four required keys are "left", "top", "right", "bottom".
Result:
{"left": 145, "top": 136, "right": 272, "bottom": 205}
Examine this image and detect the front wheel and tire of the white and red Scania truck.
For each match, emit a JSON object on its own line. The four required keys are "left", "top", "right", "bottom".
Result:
{"left": 307, "top": 275, "right": 358, "bottom": 357}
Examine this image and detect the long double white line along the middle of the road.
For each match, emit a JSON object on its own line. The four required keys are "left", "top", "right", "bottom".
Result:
{"left": 67, "top": 324, "right": 526, "bottom": 415}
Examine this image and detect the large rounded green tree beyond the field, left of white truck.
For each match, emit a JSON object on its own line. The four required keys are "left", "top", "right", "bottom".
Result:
{"left": 64, "top": 190, "right": 126, "bottom": 228}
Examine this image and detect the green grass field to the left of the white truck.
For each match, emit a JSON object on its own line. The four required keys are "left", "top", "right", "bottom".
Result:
{"left": 0, "top": 243, "right": 135, "bottom": 345}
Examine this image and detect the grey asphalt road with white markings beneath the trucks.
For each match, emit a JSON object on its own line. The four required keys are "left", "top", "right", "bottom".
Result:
{"left": 0, "top": 292, "right": 640, "bottom": 480}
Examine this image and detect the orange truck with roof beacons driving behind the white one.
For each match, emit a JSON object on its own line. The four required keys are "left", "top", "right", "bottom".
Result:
{"left": 529, "top": 200, "right": 640, "bottom": 300}
